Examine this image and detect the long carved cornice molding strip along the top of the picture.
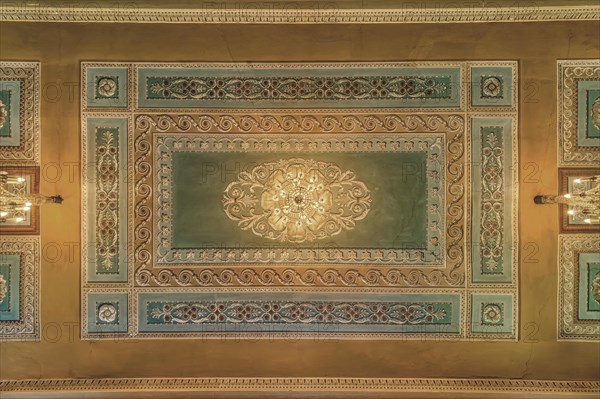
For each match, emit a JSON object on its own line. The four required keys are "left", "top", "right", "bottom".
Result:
{"left": 0, "top": 3, "right": 600, "bottom": 24}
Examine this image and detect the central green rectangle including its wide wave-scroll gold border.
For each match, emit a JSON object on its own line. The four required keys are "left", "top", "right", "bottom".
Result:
{"left": 133, "top": 113, "right": 465, "bottom": 287}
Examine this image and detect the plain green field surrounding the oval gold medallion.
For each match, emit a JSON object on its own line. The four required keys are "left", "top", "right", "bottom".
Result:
{"left": 172, "top": 152, "right": 427, "bottom": 249}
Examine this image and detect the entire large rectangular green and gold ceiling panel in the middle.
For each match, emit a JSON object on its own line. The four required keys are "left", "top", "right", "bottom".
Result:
{"left": 82, "top": 62, "right": 518, "bottom": 339}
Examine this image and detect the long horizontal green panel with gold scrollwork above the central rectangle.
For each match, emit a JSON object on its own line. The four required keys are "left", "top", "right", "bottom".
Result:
{"left": 135, "top": 63, "right": 464, "bottom": 109}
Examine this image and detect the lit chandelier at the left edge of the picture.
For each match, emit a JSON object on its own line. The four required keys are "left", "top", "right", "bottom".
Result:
{"left": 0, "top": 170, "right": 63, "bottom": 224}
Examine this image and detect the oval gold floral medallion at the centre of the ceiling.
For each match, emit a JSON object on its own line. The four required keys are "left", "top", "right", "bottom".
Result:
{"left": 223, "top": 158, "right": 371, "bottom": 243}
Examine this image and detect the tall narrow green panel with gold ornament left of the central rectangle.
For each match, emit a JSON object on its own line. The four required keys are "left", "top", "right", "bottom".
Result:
{"left": 82, "top": 114, "right": 129, "bottom": 282}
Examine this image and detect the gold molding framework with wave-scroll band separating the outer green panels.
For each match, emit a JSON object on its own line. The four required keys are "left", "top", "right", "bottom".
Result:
{"left": 81, "top": 61, "right": 519, "bottom": 340}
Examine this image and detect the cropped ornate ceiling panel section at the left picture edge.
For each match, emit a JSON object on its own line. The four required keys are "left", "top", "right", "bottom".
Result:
{"left": 0, "top": 61, "right": 41, "bottom": 341}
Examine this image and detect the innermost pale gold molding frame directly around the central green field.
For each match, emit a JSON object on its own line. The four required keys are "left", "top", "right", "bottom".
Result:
{"left": 155, "top": 133, "right": 450, "bottom": 266}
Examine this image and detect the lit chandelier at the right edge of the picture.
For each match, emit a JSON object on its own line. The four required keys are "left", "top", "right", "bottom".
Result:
{"left": 533, "top": 175, "right": 600, "bottom": 224}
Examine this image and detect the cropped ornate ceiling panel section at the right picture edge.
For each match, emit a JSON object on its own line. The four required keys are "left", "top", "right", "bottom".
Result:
{"left": 557, "top": 59, "right": 600, "bottom": 341}
